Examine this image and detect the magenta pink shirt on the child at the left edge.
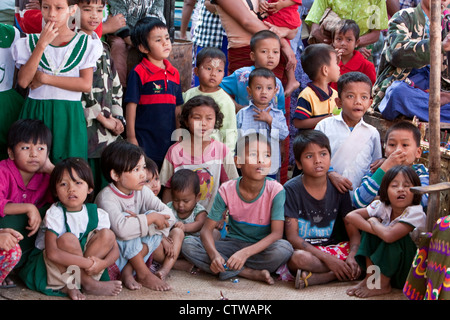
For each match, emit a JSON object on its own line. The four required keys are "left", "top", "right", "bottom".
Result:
{"left": 0, "top": 159, "right": 53, "bottom": 217}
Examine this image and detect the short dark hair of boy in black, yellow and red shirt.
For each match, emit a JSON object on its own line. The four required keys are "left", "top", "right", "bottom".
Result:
{"left": 300, "top": 43, "right": 336, "bottom": 80}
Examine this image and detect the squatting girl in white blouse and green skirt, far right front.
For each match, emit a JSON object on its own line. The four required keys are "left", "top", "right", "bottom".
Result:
{"left": 345, "top": 165, "right": 426, "bottom": 298}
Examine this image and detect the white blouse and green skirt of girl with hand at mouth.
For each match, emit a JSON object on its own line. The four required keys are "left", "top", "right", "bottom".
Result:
{"left": 13, "top": 33, "right": 103, "bottom": 163}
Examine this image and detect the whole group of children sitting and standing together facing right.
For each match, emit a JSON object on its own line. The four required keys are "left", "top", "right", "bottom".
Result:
{"left": 0, "top": 0, "right": 428, "bottom": 299}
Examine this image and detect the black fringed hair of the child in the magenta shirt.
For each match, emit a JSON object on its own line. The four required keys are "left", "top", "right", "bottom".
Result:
{"left": 7, "top": 119, "right": 53, "bottom": 154}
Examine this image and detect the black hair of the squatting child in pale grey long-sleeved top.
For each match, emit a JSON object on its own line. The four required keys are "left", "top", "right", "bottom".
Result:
{"left": 100, "top": 139, "right": 145, "bottom": 182}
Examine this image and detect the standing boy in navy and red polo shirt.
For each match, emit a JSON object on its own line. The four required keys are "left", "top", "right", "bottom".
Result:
{"left": 125, "top": 17, "right": 183, "bottom": 169}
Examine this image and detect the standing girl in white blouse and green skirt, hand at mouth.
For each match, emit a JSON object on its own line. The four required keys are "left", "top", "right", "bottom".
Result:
{"left": 13, "top": 0, "right": 102, "bottom": 163}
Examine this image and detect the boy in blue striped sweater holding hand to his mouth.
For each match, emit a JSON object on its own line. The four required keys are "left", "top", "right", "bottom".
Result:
{"left": 352, "top": 121, "right": 430, "bottom": 210}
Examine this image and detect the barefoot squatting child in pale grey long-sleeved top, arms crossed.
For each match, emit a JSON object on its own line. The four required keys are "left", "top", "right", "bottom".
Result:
{"left": 95, "top": 140, "right": 178, "bottom": 291}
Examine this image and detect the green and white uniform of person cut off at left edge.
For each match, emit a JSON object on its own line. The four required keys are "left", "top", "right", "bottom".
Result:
{"left": 0, "top": 24, "right": 24, "bottom": 160}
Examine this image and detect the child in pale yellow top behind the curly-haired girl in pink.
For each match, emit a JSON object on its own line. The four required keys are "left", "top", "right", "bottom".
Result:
{"left": 183, "top": 47, "right": 237, "bottom": 154}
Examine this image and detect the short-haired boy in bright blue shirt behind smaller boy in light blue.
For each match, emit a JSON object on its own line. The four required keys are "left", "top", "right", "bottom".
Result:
{"left": 220, "top": 30, "right": 286, "bottom": 114}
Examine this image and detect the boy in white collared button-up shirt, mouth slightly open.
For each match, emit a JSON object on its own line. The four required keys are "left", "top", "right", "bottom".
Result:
{"left": 316, "top": 72, "right": 382, "bottom": 196}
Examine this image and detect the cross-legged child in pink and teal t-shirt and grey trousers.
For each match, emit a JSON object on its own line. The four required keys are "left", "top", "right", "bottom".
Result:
{"left": 182, "top": 133, "right": 293, "bottom": 284}
